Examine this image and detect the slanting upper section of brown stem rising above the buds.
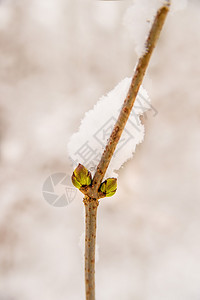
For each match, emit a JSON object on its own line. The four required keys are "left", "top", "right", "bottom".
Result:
{"left": 93, "top": 3, "right": 169, "bottom": 191}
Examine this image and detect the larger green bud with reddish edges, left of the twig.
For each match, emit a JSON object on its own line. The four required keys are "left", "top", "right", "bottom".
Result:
{"left": 72, "top": 164, "right": 92, "bottom": 189}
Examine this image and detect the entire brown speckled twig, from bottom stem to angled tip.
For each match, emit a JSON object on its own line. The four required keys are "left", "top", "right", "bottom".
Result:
{"left": 77, "top": 0, "right": 170, "bottom": 300}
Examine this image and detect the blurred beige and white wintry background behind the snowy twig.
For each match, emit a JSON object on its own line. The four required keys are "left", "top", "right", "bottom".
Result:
{"left": 0, "top": 0, "right": 200, "bottom": 300}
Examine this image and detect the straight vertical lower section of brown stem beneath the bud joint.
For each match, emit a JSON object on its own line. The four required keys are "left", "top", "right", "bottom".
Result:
{"left": 83, "top": 196, "right": 99, "bottom": 300}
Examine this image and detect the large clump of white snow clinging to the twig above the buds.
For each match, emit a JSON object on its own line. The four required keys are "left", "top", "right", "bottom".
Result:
{"left": 68, "top": 78, "right": 151, "bottom": 177}
